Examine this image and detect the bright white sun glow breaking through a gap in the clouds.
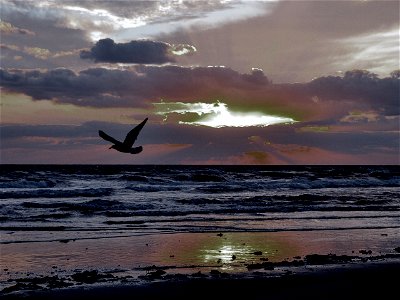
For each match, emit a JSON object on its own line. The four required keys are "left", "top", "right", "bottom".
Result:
{"left": 154, "top": 102, "right": 296, "bottom": 128}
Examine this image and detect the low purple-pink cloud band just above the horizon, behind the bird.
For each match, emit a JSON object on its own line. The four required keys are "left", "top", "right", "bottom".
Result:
{"left": 0, "top": 116, "right": 399, "bottom": 164}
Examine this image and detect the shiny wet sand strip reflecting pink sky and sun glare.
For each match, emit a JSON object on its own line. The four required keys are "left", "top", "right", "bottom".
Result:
{"left": 0, "top": 229, "right": 400, "bottom": 282}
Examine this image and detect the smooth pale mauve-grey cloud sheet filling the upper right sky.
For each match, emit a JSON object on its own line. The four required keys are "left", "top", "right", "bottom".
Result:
{"left": 158, "top": 1, "right": 399, "bottom": 83}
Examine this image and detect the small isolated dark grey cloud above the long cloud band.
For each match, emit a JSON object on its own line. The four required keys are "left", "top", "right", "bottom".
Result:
{"left": 80, "top": 39, "right": 175, "bottom": 64}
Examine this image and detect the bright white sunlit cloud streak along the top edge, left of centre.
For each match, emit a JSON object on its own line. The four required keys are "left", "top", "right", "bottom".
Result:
{"left": 2, "top": 0, "right": 250, "bottom": 41}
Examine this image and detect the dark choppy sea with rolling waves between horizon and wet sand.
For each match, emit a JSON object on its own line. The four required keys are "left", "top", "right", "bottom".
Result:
{"left": 0, "top": 165, "right": 400, "bottom": 244}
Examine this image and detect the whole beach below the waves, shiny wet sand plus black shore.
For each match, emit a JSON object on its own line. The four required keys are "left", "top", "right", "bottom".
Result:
{"left": 0, "top": 229, "right": 400, "bottom": 299}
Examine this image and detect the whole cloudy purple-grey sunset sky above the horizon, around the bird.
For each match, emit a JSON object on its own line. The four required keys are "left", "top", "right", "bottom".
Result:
{"left": 0, "top": 0, "right": 400, "bottom": 165}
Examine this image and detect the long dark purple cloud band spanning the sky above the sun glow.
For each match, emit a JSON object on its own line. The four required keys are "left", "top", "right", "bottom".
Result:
{"left": 0, "top": 65, "right": 400, "bottom": 121}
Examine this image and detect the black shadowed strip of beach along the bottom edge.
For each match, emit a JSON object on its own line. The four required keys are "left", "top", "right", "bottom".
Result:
{"left": 1, "top": 259, "right": 400, "bottom": 300}
